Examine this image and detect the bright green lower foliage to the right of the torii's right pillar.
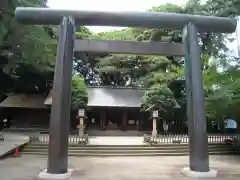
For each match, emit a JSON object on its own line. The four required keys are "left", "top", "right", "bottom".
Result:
{"left": 206, "top": 63, "right": 240, "bottom": 120}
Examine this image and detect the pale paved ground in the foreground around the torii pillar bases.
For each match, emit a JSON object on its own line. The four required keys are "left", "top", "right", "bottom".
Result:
{"left": 0, "top": 156, "right": 240, "bottom": 180}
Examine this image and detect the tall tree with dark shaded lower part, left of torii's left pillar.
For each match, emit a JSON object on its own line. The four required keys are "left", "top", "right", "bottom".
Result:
{"left": 0, "top": 0, "right": 57, "bottom": 96}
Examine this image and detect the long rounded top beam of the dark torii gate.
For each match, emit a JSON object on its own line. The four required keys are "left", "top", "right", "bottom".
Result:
{"left": 15, "top": 7, "right": 237, "bottom": 33}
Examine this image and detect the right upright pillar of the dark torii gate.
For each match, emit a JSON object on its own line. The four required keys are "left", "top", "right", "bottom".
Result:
{"left": 183, "top": 23, "right": 209, "bottom": 172}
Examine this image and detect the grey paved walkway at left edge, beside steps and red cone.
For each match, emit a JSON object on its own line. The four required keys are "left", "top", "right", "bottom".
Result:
{"left": 0, "top": 132, "right": 29, "bottom": 158}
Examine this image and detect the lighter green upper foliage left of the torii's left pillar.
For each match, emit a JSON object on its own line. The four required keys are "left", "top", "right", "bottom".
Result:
{"left": 0, "top": 0, "right": 56, "bottom": 73}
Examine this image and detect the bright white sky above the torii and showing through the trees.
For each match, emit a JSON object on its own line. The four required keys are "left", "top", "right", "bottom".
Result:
{"left": 47, "top": 0, "right": 240, "bottom": 56}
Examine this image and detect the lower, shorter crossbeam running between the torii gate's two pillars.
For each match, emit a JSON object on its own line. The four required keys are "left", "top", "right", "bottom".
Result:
{"left": 74, "top": 39, "right": 184, "bottom": 56}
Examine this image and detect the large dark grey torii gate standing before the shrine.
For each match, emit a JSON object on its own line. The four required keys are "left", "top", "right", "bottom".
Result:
{"left": 15, "top": 7, "right": 237, "bottom": 179}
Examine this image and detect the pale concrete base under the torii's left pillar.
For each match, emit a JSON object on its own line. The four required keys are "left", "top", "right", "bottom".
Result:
{"left": 38, "top": 169, "right": 73, "bottom": 180}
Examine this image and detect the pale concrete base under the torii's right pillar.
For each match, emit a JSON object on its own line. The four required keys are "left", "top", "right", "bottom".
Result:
{"left": 181, "top": 167, "right": 217, "bottom": 178}
